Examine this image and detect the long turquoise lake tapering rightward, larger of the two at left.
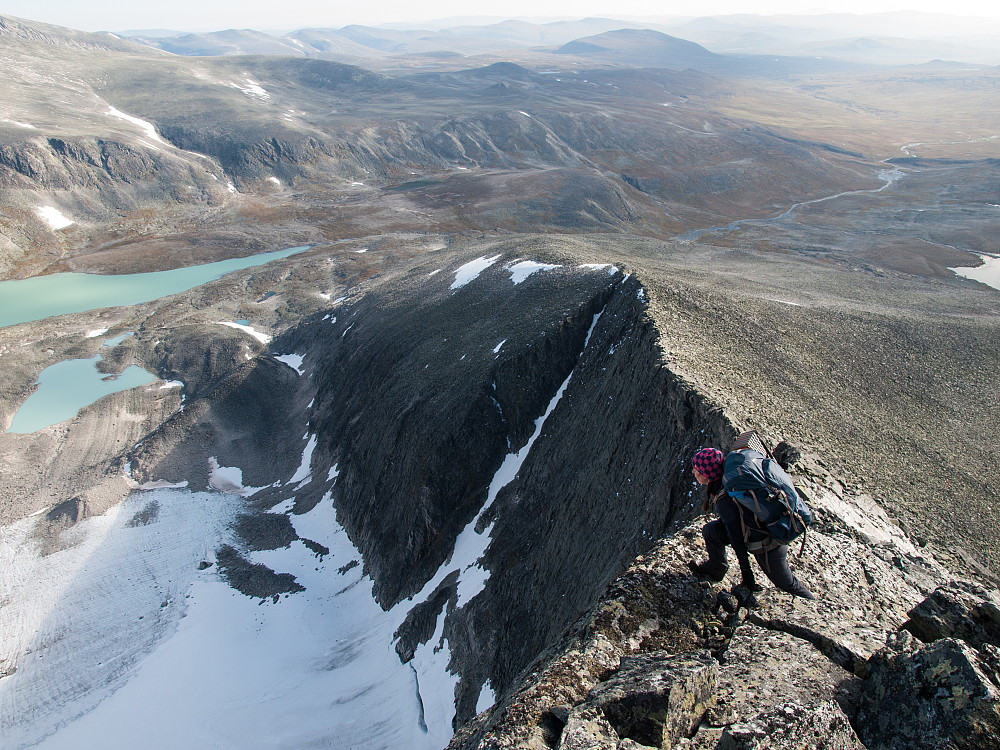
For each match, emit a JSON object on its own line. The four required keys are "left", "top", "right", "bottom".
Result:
{"left": 0, "top": 245, "right": 310, "bottom": 328}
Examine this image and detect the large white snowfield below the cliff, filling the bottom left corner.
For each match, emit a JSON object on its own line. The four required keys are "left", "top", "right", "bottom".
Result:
{"left": 0, "top": 489, "right": 455, "bottom": 750}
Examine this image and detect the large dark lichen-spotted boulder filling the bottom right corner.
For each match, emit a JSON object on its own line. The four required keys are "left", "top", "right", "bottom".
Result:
{"left": 855, "top": 631, "right": 1000, "bottom": 750}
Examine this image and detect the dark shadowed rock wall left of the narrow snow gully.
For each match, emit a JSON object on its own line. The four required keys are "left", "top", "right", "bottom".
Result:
{"left": 283, "top": 266, "right": 620, "bottom": 607}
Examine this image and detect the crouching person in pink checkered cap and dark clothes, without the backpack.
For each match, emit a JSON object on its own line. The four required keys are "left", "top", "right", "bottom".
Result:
{"left": 688, "top": 448, "right": 815, "bottom": 599}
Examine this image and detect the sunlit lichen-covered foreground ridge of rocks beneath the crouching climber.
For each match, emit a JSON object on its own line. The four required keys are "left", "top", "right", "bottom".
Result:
{"left": 449, "top": 459, "right": 1000, "bottom": 750}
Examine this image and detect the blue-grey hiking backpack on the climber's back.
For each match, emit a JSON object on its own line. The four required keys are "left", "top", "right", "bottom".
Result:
{"left": 722, "top": 449, "right": 813, "bottom": 544}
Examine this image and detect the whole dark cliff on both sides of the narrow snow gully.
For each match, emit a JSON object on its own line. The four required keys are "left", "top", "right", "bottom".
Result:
{"left": 272, "top": 263, "right": 733, "bottom": 723}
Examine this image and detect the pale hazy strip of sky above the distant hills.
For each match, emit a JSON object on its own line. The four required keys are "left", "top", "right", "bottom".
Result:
{"left": 0, "top": 0, "right": 1000, "bottom": 31}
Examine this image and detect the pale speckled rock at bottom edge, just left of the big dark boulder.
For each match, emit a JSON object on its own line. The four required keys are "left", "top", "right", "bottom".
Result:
{"left": 717, "top": 701, "right": 865, "bottom": 750}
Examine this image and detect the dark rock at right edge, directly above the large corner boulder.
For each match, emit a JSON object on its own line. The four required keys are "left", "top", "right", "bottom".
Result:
{"left": 906, "top": 581, "right": 1000, "bottom": 649}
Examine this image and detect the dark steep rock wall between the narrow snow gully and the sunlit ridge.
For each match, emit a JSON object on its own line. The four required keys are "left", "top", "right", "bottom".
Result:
{"left": 445, "top": 278, "right": 733, "bottom": 721}
